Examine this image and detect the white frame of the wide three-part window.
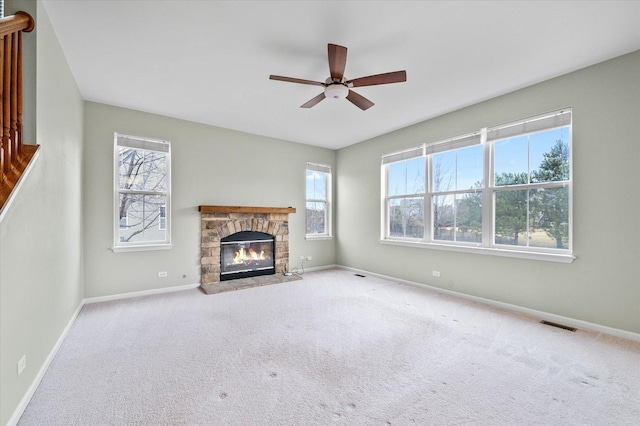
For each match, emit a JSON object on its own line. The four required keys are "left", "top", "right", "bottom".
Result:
{"left": 380, "top": 108, "right": 575, "bottom": 263}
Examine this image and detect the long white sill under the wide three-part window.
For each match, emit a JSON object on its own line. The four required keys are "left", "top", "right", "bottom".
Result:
{"left": 380, "top": 240, "right": 576, "bottom": 263}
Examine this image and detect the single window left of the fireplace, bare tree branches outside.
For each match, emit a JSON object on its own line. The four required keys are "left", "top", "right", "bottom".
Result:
{"left": 113, "top": 134, "right": 171, "bottom": 251}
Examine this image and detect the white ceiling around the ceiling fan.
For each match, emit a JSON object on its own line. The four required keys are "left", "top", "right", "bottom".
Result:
{"left": 43, "top": 0, "right": 640, "bottom": 149}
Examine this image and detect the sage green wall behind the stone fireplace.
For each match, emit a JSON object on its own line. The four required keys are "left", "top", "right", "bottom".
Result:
{"left": 84, "top": 102, "right": 335, "bottom": 297}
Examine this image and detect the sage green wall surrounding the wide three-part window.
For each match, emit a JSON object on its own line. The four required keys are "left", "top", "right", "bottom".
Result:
{"left": 336, "top": 52, "right": 640, "bottom": 333}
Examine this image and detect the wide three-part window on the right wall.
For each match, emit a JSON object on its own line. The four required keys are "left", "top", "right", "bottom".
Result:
{"left": 382, "top": 109, "right": 572, "bottom": 260}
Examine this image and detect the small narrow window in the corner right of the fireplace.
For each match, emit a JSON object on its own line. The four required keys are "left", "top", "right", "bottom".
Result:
{"left": 306, "top": 163, "right": 331, "bottom": 238}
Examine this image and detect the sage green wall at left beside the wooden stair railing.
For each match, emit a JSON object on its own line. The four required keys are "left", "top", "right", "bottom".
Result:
{"left": 0, "top": 1, "right": 83, "bottom": 425}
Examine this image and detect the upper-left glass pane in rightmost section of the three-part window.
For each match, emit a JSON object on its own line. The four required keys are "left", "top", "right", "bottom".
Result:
{"left": 493, "top": 135, "right": 529, "bottom": 186}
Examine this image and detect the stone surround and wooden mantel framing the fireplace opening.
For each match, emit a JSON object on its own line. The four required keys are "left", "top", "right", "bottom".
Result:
{"left": 199, "top": 206, "right": 296, "bottom": 285}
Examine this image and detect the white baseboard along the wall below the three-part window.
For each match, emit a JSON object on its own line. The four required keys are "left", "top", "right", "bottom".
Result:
{"left": 335, "top": 265, "right": 640, "bottom": 342}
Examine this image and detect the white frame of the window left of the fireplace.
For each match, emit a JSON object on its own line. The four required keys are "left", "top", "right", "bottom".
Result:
{"left": 111, "top": 132, "right": 173, "bottom": 253}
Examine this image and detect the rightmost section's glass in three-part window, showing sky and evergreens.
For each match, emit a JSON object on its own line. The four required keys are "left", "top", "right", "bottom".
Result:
{"left": 495, "top": 127, "right": 570, "bottom": 249}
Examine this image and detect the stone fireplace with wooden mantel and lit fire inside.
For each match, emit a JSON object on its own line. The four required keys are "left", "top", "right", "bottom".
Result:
{"left": 199, "top": 206, "right": 296, "bottom": 285}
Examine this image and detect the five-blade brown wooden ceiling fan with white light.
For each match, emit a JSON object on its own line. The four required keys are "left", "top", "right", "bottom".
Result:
{"left": 269, "top": 44, "right": 407, "bottom": 111}
